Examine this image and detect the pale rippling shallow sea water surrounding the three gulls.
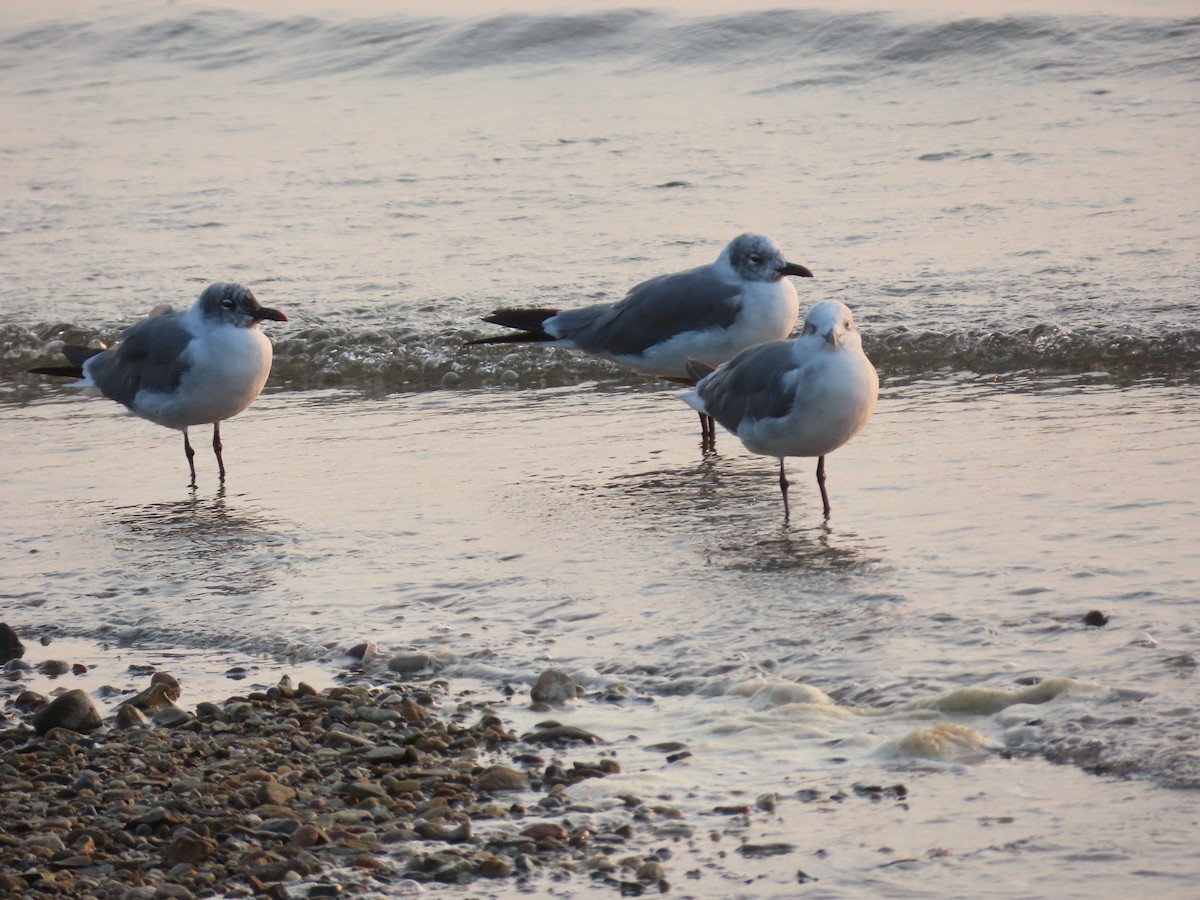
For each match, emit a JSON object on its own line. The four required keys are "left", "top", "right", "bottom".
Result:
{"left": 0, "top": 4, "right": 1200, "bottom": 896}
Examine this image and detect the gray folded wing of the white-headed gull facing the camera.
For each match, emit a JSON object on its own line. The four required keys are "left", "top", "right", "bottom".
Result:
{"left": 696, "top": 341, "right": 804, "bottom": 434}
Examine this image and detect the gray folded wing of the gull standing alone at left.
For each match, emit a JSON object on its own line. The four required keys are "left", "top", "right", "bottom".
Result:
{"left": 86, "top": 312, "right": 192, "bottom": 408}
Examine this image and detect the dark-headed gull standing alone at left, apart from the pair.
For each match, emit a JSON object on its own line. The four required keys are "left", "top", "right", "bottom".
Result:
{"left": 30, "top": 282, "right": 288, "bottom": 487}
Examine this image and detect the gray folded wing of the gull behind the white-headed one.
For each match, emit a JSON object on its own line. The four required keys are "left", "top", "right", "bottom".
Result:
{"left": 554, "top": 265, "right": 742, "bottom": 355}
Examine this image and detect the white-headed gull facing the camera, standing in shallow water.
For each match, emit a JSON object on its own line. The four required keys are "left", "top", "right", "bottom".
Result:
{"left": 682, "top": 300, "right": 880, "bottom": 522}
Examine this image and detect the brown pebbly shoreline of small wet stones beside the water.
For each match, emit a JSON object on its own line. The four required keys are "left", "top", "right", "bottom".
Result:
{"left": 0, "top": 628, "right": 691, "bottom": 900}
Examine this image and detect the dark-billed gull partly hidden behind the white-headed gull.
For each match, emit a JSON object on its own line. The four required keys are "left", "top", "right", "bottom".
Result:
{"left": 469, "top": 234, "right": 812, "bottom": 437}
